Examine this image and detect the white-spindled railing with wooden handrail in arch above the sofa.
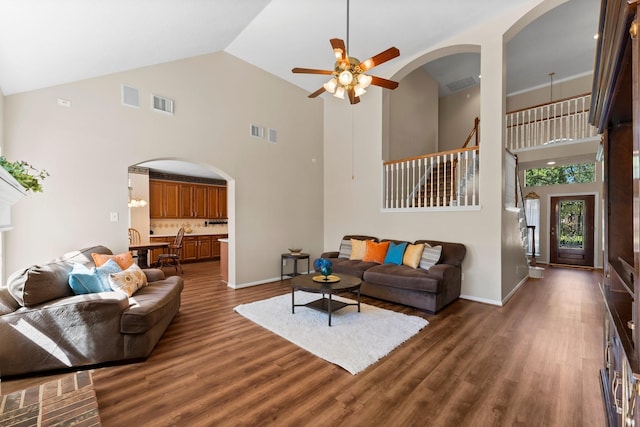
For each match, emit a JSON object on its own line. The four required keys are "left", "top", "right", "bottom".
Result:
{"left": 383, "top": 118, "right": 480, "bottom": 210}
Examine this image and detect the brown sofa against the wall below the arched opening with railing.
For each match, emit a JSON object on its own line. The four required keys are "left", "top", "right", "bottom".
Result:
{"left": 321, "top": 235, "right": 466, "bottom": 313}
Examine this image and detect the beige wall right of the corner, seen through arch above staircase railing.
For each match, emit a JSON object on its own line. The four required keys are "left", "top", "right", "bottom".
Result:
{"left": 438, "top": 85, "right": 482, "bottom": 151}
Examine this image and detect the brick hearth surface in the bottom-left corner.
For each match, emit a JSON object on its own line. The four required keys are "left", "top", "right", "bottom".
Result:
{"left": 0, "top": 371, "right": 102, "bottom": 427}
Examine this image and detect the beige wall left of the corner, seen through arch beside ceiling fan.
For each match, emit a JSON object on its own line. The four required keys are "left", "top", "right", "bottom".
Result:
{"left": 384, "top": 67, "right": 438, "bottom": 160}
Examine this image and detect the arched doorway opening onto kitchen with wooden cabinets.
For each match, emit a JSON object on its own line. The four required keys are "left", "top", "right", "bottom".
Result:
{"left": 128, "top": 158, "right": 235, "bottom": 283}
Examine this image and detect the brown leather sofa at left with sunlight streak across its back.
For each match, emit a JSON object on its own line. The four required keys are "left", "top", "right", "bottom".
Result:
{"left": 0, "top": 246, "right": 184, "bottom": 377}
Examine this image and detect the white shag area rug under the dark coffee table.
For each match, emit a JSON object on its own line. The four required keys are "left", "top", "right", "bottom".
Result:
{"left": 234, "top": 291, "right": 429, "bottom": 375}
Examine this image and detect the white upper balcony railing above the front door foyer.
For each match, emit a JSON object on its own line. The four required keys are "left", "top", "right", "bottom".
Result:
{"left": 505, "top": 94, "right": 598, "bottom": 152}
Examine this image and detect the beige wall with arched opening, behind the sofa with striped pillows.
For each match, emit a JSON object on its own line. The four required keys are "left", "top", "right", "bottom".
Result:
{"left": 324, "top": 2, "right": 540, "bottom": 304}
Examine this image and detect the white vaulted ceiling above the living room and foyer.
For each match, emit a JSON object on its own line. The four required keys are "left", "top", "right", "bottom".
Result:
{"left": 0, "top": 0, "right": 599, "bottom": 95}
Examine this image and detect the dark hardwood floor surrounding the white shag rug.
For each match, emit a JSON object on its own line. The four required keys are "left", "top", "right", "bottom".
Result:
{"left": 2, "top": 262, "right": 605, "bottom": 426}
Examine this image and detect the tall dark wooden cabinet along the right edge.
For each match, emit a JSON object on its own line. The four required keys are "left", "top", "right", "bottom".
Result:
{"left": 591, "top": 0, "right": 640, "bottom": 426}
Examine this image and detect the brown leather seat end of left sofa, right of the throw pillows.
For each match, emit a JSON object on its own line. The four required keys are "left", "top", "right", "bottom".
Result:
{"left": 120, "top": 276, "right": 184, "bottom": 334}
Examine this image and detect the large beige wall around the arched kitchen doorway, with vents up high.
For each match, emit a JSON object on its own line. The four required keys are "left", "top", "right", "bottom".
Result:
{"left": 4, "top": 52, "right": 323, "bottom": 286}
